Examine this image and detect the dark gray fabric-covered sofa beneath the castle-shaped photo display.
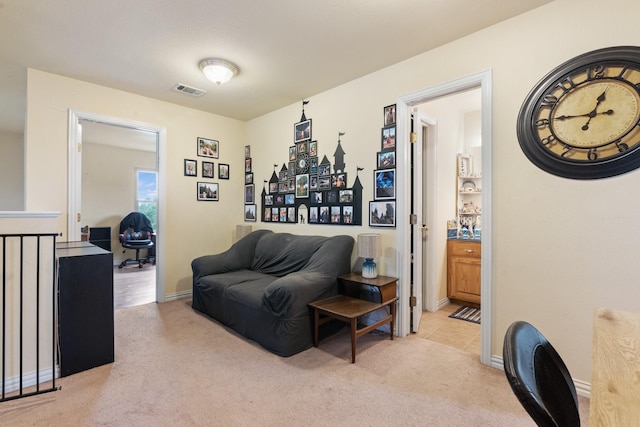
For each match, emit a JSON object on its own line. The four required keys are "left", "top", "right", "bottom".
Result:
{"left": 191, "top": 230, "right": 354, "bottom": 356}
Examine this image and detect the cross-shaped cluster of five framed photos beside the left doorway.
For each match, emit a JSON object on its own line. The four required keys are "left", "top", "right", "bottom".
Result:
{"left": 184, "top": 137, "right": 229, "bottom": 202}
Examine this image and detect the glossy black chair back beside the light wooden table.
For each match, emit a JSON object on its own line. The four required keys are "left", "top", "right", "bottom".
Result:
{"left": 502, "top": 321, "right": 580, "bottom": 427}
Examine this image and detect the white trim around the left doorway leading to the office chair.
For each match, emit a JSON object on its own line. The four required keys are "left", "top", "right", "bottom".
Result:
{"left": 67, "top": 109, "right": 167, "bottom": 302}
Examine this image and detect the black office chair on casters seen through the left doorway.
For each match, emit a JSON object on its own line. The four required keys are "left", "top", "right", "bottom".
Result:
{"left": 118, "top": 212, "right": 155, "bottom": 268}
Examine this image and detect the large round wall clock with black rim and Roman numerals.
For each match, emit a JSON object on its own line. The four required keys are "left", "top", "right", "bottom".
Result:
{"left": 517, "top": 46, "right": 640, "bottom": 179}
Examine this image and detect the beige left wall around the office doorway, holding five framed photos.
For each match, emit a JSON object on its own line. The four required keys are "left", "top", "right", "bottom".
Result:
{"left": 26, "top": 69, "right": 245, "bottom": 296}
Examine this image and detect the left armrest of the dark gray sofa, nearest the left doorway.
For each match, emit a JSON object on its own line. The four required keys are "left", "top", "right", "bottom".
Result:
{"left": 191, "top": 230, "right": 271, "bottom": 283}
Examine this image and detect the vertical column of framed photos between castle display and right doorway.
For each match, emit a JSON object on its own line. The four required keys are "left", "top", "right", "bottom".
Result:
{"left": 369, "top": 104, "right": 396, "bottom": 227}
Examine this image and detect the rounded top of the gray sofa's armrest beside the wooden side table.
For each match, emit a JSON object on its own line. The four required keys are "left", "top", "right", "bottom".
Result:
{"left": 263, "top": 270, "right": 338, "bottom": 319}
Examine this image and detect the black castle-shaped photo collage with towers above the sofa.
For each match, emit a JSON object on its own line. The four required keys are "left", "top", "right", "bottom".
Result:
{"left": 260, "top": 101, "right": 362, "bottom": 225}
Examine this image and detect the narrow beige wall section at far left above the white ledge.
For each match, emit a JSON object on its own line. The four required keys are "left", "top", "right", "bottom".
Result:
{"left": 0, "top": 132, "right": 24, "bottom": 211}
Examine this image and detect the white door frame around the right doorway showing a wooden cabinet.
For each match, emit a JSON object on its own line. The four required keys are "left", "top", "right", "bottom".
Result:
{"left": 396, "top": 70, "right": 493, "bottom": 365}
